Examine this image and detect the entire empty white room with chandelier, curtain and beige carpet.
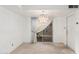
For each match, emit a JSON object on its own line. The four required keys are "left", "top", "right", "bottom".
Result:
{"left": 0, "top": 5, "right": 79, "bottom": 54}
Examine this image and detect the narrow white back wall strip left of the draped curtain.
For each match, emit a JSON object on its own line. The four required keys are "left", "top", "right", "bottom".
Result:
{"left": 24, "top": 16, "right": 32, "bottom": 43}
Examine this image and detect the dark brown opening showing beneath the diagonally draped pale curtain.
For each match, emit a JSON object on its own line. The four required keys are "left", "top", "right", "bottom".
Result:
{"left": 37, "top": 23, "right": 53, "bottom": 42}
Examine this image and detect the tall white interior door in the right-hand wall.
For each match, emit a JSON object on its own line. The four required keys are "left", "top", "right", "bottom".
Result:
{"left": 67, "top": 15, "right": 75, "bottom": 49}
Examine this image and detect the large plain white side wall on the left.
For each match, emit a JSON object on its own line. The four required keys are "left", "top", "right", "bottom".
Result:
{"left": 0, "top": 7, "right": 25, "bottom": 53}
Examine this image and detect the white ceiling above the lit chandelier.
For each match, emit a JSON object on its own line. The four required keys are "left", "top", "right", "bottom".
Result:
{"left": 2, "top": 5, "right": 77, "bottom": 17}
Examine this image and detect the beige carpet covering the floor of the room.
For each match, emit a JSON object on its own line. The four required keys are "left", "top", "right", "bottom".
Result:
{"left": 11, "top": 42, "right": 74, "bottom": 54}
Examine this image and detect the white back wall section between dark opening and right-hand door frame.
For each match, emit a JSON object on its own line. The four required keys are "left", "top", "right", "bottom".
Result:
{"left": 53, "top": 17, "right": 66, "bottom": 44}
